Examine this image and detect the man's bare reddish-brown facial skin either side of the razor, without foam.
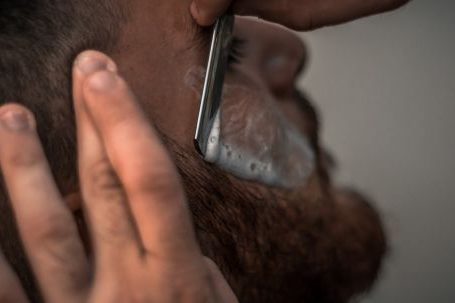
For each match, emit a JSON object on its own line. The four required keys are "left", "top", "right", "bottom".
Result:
{"left": 112, "top": 1, "right": 310, "bottom": 173}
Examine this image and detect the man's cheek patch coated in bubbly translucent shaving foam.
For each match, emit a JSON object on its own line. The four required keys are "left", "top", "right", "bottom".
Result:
{"left": 207, "top": 75, "right": 314, "bottom": 188}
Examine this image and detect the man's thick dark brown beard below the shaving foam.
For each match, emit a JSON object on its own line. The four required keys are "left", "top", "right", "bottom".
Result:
{"left": 165, "top": 138, "right": 386, "bottom": 303}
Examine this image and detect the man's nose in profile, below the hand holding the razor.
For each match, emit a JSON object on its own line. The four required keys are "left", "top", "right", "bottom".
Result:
{"left": 235, "top": 18, "right": 308, "bottom": 97}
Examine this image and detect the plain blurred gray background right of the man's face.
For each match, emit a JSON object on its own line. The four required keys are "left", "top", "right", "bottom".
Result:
{"left": 302, "top": 0, "right": 455, "bottom": 303}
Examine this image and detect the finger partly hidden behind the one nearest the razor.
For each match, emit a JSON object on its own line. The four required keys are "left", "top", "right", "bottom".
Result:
{"left": 73, "top": 51, "right": 139, "bottom": 270}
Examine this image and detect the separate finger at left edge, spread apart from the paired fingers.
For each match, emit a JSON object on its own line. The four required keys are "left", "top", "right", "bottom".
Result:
{"left": 0, "top": 104, "right": 88, "bottom": 302}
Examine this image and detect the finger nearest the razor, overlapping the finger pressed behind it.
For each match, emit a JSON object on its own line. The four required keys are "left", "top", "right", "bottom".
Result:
{"left": 84, "top": 72, "right": 200, "bottom": 258}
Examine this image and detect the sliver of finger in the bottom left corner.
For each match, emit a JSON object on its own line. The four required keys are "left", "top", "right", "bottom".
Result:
{"left": 0, "top": 252, "right": 28, "bottom": 303}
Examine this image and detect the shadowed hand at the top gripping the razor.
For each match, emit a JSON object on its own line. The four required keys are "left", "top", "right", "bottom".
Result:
{"left": 191, "top": 0, "right": 409, "bottom": 30}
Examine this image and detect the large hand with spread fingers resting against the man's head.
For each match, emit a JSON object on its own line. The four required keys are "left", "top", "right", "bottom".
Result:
{"left": 0, "top": 51, "right": 237, "bottom": 303}
